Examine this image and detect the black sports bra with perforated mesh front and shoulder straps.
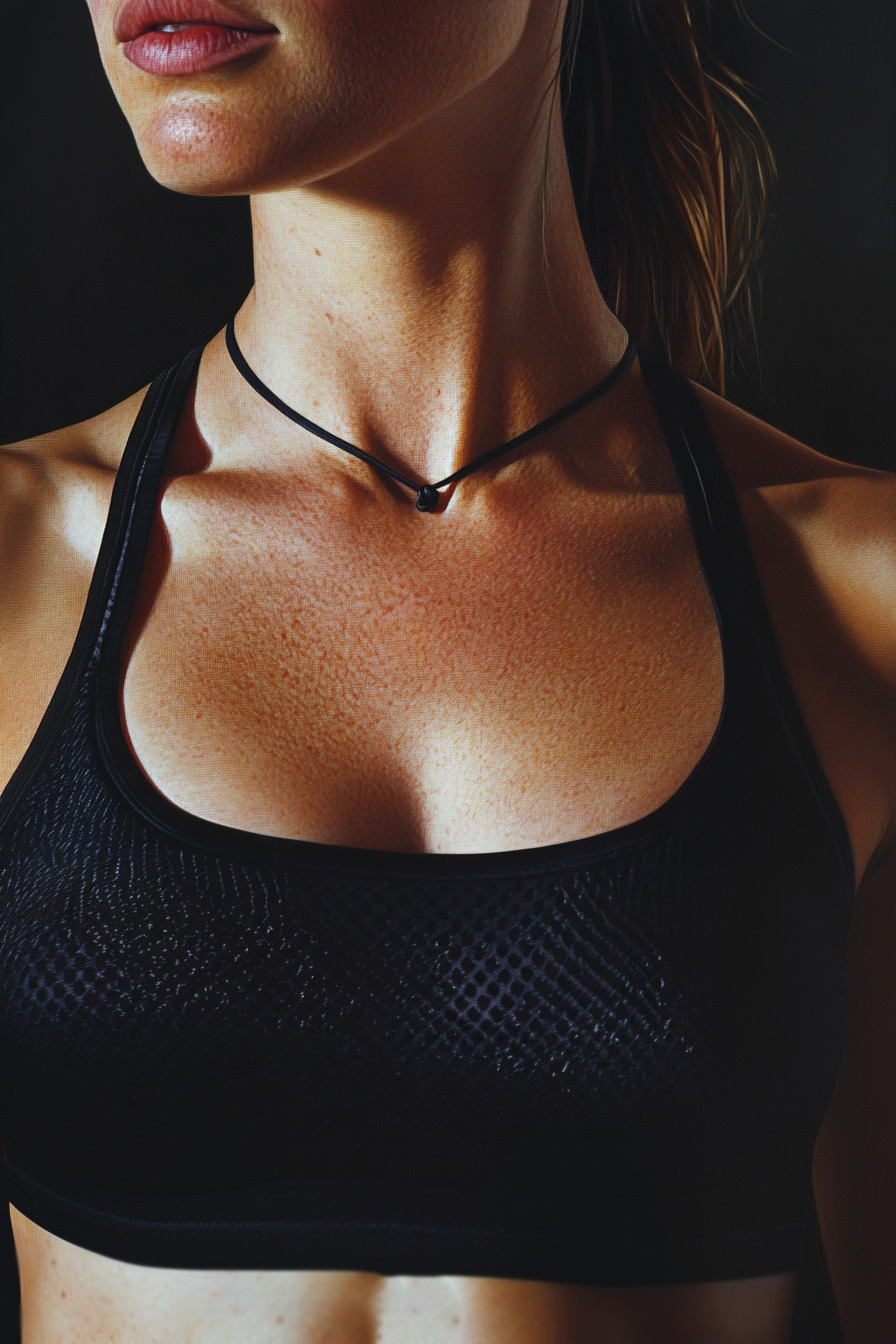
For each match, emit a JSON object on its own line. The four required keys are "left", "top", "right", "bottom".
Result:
{"left": 0, "top": 338, "right": 854, "bottom": 1285}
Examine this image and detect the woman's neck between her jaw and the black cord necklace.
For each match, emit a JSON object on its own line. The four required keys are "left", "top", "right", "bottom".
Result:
{"left": 213, "top": 43, "right": 626, "bottom": 494}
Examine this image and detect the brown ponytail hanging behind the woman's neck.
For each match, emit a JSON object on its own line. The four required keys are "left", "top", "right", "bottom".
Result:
{"left": 557, "top": 0, "right": 775, "bottom": 394}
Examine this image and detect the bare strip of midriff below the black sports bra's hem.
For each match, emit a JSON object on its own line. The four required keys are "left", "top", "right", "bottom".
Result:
{"left": 9, "top": 1206, "right": 795, "bottom": 1344}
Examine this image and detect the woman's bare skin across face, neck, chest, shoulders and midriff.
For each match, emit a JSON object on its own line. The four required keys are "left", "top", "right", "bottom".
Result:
{"left": 0, "top": 0, "right": 896, "bottom": 1344}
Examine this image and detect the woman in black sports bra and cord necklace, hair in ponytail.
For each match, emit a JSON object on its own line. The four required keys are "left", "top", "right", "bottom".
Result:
{"left": 0, "top": 0, "right": 896, "bottom": 1344}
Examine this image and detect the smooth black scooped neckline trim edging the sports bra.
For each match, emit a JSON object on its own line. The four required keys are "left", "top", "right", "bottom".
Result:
{"left": 94, "top": 347, "right": 746, "bottom": 876}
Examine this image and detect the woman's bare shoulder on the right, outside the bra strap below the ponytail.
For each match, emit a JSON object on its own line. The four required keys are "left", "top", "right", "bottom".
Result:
{"left": 695, "top": 384, "right": 896, "bottom": 837}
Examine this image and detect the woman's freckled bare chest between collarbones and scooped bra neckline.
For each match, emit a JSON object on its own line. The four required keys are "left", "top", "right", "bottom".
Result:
{"left": 122, "top": 486, "right": 724, "bottom": 851}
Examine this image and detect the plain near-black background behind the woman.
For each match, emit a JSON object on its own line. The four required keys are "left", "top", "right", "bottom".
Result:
{"left": 0, "top": 0, "right": 896, "bottom": 1344}
